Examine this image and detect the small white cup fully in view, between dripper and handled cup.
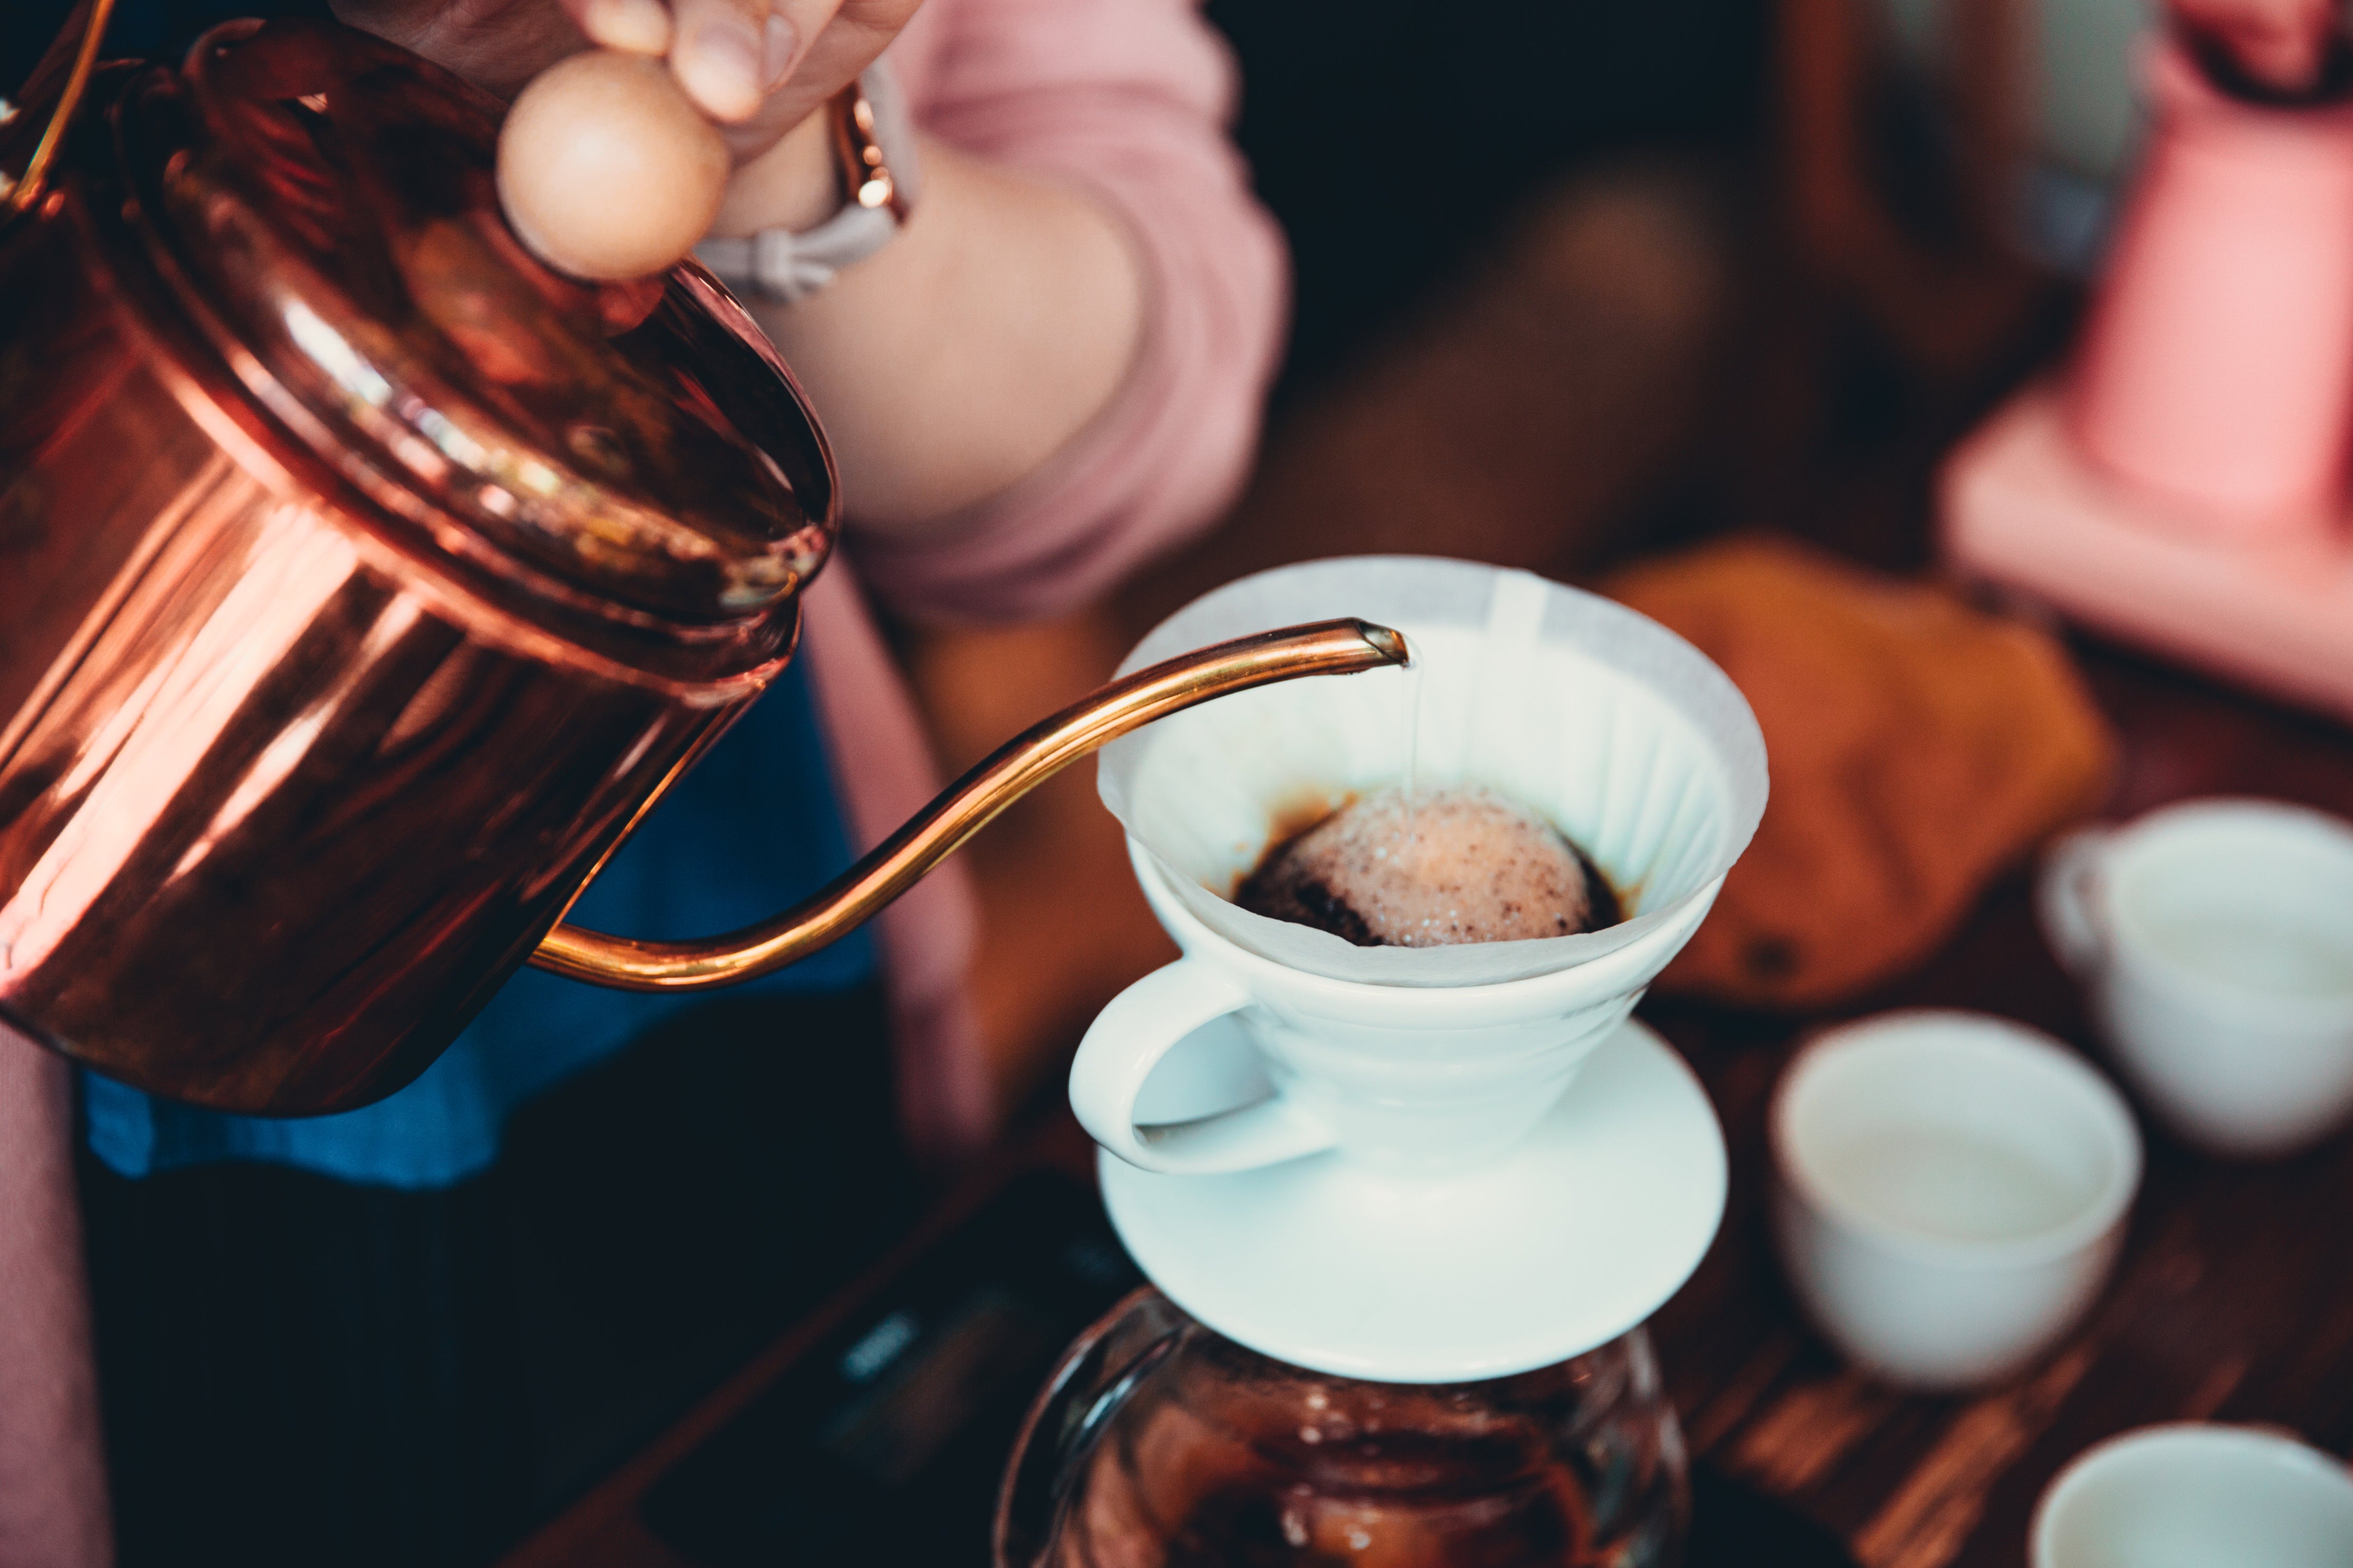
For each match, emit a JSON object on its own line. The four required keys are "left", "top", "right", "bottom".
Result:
{"left": 1772, "top": 1011, "right": 2141, "bottom": 1387}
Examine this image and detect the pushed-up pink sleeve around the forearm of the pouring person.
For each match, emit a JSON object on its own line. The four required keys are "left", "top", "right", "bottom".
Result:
{"left": 849, "top": 0, "right": 1287, "bottom": 621}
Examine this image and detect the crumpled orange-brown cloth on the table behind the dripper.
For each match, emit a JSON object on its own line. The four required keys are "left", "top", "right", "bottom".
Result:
{"left": 1602, "top": 538, "right": 2116, "bottom": 1008}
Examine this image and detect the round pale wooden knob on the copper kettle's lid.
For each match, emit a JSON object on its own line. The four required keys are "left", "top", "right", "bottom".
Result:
{"left": 499, "top": 50, "right": 730, "bottom": 282}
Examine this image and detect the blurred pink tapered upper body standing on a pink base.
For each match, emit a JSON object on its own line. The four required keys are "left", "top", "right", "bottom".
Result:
{"left": 2068, "top": 37, "right": 2353, "bottom": 536}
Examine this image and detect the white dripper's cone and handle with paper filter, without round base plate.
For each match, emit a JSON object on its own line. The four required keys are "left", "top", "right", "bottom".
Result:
{"left": 1070, "top": 557, "right": 1765, "bottom": 1173}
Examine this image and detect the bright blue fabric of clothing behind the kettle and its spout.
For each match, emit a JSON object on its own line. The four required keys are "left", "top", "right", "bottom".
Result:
{"left": 82, "top": 665, "right": 875, "bottom": 1189}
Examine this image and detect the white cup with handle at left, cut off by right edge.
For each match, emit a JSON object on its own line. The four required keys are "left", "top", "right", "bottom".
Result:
{"left": 2040, "top": 799, "right": 2353, "bottom": 1157}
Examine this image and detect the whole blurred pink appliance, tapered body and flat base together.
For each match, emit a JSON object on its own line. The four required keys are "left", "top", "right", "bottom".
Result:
{"left": 1939, "top": 24, "right": 2353, "bottom": 719}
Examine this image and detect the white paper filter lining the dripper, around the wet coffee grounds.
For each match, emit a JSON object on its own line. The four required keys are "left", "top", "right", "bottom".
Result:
{"left": 1096, "top": 555, "right": 1765, "bottom": 985}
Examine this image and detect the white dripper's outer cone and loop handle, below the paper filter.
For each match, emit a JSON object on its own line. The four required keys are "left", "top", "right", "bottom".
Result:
{"left": 1070, "top": 839, "right": 1723, "bottom": 1176}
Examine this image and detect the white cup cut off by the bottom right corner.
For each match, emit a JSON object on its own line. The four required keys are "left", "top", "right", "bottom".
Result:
{"left": 2031, "top": 1422, "right": 2353, "bottom": 1568}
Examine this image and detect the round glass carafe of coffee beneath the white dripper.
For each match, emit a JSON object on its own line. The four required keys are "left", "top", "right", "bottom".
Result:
{"left": 996, "top": 1288, "right": 1689, "bottom": 1568}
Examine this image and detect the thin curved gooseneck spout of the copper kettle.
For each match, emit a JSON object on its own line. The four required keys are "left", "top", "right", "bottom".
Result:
{"left": 532, "top": 621, "right": 1412, "bottom": 992}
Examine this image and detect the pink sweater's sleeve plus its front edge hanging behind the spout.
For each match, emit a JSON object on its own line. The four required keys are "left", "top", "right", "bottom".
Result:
{"left": 802, "top": 0, "right": 1287, "bottom": 1155}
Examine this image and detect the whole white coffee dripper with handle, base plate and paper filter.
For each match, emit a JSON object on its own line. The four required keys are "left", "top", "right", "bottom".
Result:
{"left": 1070, "top": 557, "right": 1765, "bottom": 1382}
